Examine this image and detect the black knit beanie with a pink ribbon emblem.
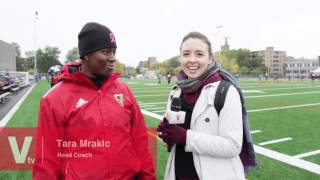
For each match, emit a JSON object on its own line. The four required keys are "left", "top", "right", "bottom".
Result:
{"left": 78, "top": 22, "right": 117, "bottom": 58}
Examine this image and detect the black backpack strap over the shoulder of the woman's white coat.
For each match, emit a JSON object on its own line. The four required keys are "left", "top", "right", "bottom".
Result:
{"left": 214, "top": 80, "right": 231, "bottom": 116}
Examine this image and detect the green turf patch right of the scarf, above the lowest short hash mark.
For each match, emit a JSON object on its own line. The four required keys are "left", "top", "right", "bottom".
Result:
{"left": 249, "top": 105, "right": 320, "bottom": 155}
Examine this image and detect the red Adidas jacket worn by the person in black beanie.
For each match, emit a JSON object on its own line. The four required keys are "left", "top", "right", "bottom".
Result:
{"left": 32, "top": 64, "right": 156, "bottom": 180}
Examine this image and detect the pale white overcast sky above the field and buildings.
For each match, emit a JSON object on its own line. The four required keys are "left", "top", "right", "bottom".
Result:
{"left": 0, "top": 0, "right": 320, "bottom": 66}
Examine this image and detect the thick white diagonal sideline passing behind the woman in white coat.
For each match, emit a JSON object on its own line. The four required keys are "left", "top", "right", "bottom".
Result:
{"left": 141, "top": 109, "right": 320, "bottom": 174}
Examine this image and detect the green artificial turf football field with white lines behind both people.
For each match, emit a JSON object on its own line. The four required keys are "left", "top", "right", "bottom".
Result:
{"left": 0, "top": 79, "right": 320, "bottom": 180}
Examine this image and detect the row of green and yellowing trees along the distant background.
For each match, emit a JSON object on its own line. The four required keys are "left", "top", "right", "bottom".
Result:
{"left": 12, "top": 43, "right": 266, "bottom": 76}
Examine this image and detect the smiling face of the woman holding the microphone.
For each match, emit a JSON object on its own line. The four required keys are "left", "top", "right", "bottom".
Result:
{"left": 180, "top": 37, "right": 212, "bottom": 79}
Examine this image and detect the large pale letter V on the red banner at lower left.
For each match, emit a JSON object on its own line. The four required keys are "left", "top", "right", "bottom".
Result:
{"left": 8, "top": 136, "right": 32, "bottom": 164}
